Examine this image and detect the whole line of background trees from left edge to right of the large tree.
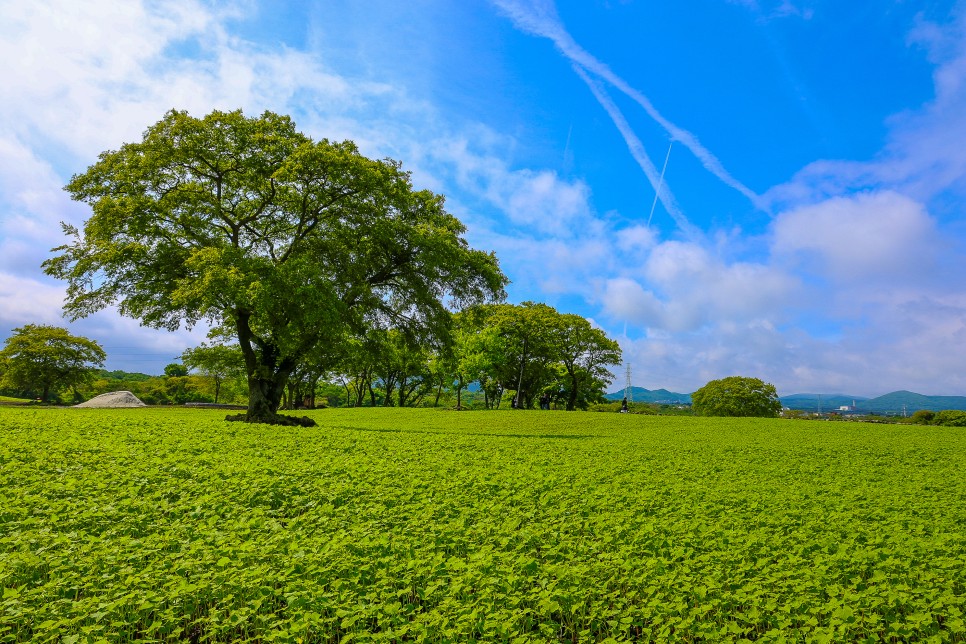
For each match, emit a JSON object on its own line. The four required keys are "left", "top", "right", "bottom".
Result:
{"left": 0, "top": 302, "right": 621, "bottom": 410}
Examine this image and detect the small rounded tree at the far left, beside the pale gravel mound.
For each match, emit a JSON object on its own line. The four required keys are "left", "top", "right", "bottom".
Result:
{"left": 0, "top": 324, "right": 107, "bottom": 402}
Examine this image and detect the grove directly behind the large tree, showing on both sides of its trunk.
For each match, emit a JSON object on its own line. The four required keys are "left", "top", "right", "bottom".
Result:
{"left": 182, "top": 302, "right": 621, "bottom": 410}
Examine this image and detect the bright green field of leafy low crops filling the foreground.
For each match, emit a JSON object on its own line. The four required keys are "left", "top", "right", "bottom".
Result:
{"left": 0, "top": 407, "right": 966, "bottom": 643}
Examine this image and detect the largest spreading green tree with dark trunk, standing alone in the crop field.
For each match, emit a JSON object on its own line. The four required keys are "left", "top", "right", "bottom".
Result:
{"left": 44, "top": 111, "right": 506, "bottom": 422}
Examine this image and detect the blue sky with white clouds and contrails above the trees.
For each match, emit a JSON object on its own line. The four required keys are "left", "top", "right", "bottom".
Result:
{"left": 0, "top": 0, "right": 966, "bottom": 396}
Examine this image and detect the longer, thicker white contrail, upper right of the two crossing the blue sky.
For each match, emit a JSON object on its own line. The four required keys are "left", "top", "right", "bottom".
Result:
{"left": 491, "top": 0, "right": 765, "bottom": 210}
